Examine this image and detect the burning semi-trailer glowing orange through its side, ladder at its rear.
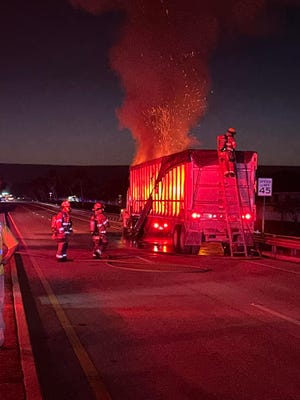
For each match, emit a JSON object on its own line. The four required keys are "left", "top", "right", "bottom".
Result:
{"left": 123, "top": 130, "right": 257, "bottom": 256}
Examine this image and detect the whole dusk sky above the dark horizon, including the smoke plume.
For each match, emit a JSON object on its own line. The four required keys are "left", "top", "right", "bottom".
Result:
{"left": 0, "top": 0, "right": 300, "bottom": 165}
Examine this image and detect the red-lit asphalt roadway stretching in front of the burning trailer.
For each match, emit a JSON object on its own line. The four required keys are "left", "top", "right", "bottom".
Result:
{"left": 4, "top": 204, "right": 300, "bottom": 400}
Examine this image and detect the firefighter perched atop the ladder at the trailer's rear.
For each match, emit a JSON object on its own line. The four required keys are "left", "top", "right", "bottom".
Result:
{"left": 218, "top": 128, "right": 236, "bottom": 177}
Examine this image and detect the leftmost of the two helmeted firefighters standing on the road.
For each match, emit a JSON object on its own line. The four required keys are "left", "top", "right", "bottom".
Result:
{"left": 54, "top": 200, "right": 73, "bottom": 262}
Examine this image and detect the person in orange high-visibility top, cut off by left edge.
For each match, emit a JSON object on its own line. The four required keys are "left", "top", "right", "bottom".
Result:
{"left": 0, "top": 224, "right": 18, "bottom": 347}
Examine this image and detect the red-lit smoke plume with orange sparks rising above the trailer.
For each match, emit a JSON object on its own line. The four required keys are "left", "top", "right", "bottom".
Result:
{"left": 70, "top": 0, "right": 298, "bottom": 163}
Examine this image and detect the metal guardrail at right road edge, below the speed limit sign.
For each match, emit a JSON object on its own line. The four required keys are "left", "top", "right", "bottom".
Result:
{"left": 254, "top": 233, "right": 300, "bottom": 263}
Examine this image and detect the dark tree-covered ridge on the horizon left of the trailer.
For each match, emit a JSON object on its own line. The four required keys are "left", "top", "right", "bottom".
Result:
{"left": 0, "top": 166, "right": 129, "bottom": 202}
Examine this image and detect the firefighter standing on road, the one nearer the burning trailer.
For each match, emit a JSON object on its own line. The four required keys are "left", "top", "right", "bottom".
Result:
{"left": 90, "top": 202, "right": 109, "bottom": 258}
